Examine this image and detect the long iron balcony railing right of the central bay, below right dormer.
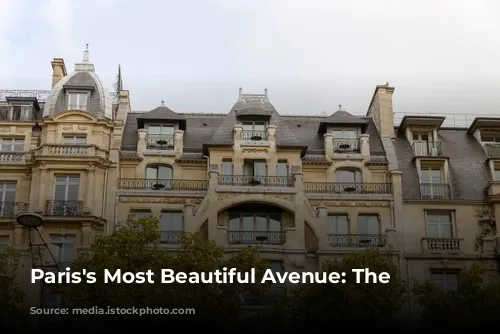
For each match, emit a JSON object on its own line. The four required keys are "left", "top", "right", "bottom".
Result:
{"left": 304, "top": 182, "right": 392, "bottom": 194}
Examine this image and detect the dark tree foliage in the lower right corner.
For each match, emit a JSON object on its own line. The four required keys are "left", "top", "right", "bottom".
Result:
{"left": 412, "top": 263, "right": 500, "bottom": 328}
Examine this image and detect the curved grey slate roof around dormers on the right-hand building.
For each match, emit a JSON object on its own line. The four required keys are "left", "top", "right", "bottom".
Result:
{"left": 394, "top": 129, "right": 491, "bottom": 201}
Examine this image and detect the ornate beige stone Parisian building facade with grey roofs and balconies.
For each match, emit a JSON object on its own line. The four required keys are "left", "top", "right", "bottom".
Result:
{"left": 0, "top": 50, "right": 500, "bottom": 314}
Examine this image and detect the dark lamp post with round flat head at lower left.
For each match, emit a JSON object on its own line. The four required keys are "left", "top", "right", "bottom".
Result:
{"left": 16, "top": 212, "right": 62, "bottom": 326}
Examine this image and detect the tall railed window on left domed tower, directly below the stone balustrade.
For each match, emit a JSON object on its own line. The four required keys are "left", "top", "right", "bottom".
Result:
{"left": 52, "top": 175, "right": 81, "bottom": 216}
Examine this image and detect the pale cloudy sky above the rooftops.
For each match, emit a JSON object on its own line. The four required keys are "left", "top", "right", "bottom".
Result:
{"left": 0, "top": 0, "right": 500, "bottom": 115}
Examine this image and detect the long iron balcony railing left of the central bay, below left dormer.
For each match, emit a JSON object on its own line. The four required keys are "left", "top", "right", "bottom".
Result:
{"left": 118, "top": 179, "right": 208, "bottom": 191}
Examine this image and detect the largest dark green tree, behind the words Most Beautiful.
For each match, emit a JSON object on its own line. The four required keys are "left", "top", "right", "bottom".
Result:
{"left": 61, "top": 217, "right": 269, "bottom": 320}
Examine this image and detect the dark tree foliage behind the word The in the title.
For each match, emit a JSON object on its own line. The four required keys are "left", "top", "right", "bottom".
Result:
{"left": 288, "top": 249, "right": 405, "bottom": 325}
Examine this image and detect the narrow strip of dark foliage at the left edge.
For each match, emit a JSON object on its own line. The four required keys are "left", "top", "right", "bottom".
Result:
{"left": 0, "top": 247, "right": 24, "bottom": 324}
